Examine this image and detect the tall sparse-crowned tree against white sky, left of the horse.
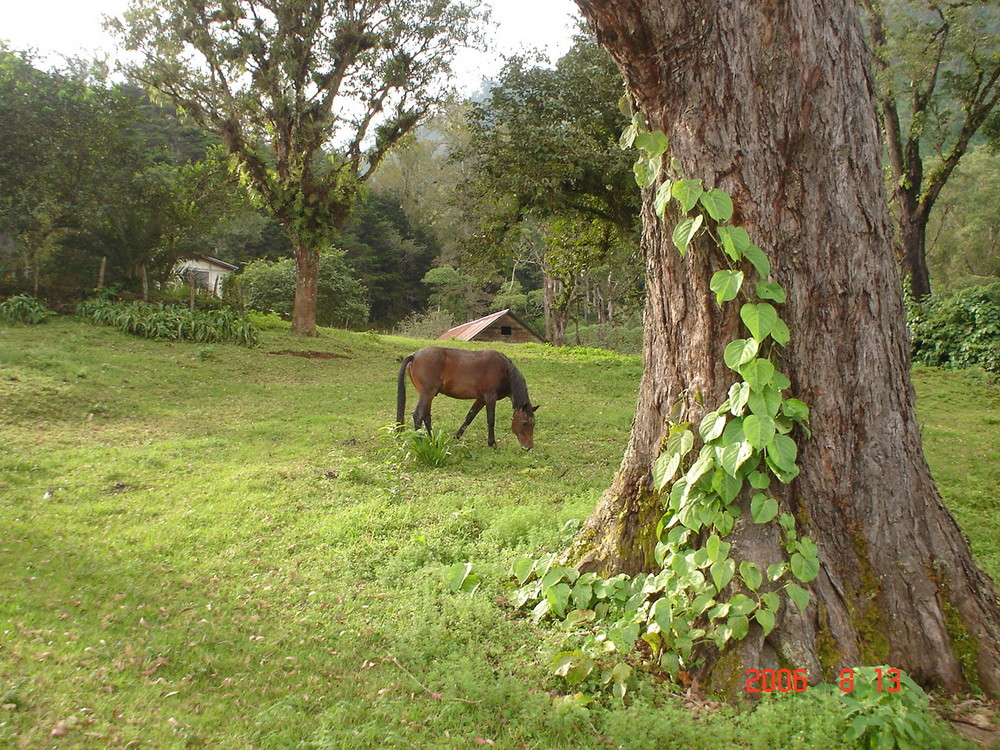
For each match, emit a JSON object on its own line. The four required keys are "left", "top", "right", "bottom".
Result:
{"left": 113, "top": 0, "right": 478, "bottom": 335}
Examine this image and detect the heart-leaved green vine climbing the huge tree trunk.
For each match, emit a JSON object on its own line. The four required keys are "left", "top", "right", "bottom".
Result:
{"left": 496, "top": 107, "right": 819, "bottom": 697}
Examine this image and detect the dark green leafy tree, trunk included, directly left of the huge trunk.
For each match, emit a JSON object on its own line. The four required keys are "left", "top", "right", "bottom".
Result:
{"left": 463, "top": 34, "right": 638, "bottom": 345}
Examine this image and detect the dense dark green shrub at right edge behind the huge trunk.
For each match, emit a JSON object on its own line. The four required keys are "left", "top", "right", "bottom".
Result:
{"left": 906, "top": 283, "right": 1000, "bottom": 373}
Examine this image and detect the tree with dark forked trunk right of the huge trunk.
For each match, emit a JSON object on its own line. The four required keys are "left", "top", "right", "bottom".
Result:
{"left": 862, "top": 0, "right": 1000, "bottom": 299}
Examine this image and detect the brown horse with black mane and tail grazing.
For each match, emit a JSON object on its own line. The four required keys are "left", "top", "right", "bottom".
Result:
{"left": 396, "top": 346, "right": 538, "bottom": 449}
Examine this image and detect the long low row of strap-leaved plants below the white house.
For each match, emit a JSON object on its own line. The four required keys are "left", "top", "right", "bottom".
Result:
{"left": 76, "top": 299, "right": 259, "bottom": 346}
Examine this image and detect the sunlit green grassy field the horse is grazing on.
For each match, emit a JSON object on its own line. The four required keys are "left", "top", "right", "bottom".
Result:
{"left": 0, "top": 319, "right": 1000, "bottom": 749}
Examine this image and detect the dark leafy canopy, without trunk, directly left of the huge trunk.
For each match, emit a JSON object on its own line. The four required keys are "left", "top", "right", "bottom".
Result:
{"left": 468, "top": 35, "right": 638, "bottom": 250}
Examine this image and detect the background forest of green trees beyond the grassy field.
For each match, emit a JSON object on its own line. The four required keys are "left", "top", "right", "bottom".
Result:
{"left": 0, "top": 4, "right": 1000, "bottom": 351}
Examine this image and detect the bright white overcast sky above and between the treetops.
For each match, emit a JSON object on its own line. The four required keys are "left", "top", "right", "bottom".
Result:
{"left": 0, "top": 0, "right": 577, "bottom": 93}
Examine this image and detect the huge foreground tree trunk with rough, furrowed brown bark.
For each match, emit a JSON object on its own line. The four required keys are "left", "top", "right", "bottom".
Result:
{"left": 572, "top": 0, "right": 1000, "bottom": 691}
